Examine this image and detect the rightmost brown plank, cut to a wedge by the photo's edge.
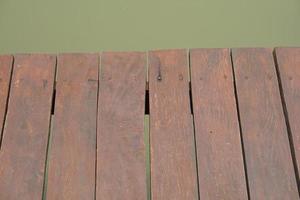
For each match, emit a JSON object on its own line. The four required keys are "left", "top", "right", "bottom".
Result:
{"left": 275, "top": 48, "right": 300, "bottom": 183}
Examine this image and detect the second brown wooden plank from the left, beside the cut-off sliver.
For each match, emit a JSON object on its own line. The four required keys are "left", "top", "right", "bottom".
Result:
{"left": 0, "top": 54, "right": 56, "bottom": 200}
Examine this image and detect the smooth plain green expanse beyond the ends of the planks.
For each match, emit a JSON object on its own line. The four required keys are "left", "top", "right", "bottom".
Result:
{"left": 0, "top": 0, "right": 300, "bottom": 53}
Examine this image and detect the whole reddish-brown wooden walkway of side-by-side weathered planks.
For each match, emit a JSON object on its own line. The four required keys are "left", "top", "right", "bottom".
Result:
{"left": 0, "top": 48, "right": 300, "bottom": 200}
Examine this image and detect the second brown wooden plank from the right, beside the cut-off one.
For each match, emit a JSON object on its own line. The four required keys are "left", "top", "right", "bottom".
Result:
{"left": 232, "top": 48, "right": 299, "bottom": 200}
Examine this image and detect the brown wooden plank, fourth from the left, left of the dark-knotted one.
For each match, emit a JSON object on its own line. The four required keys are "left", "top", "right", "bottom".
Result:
{"left": 96, "top": 52, "right": 147, "bottom": 200}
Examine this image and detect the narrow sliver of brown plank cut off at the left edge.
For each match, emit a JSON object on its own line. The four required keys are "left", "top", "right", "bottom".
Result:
{"left": 0, "top": 55, "right": 13, "bottom": 145}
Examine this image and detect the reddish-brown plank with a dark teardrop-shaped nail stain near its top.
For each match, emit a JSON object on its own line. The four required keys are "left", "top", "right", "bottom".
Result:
{"left": 149, "top": 50, "right": 198, "bottom": 200}
